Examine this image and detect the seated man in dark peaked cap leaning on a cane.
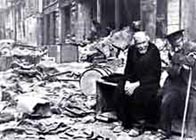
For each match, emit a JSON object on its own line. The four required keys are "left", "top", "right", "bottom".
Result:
{"left": 159, "top": 30, "right": 196, "bottom": 139}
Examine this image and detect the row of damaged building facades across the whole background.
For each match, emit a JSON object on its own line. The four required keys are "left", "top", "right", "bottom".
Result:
{"left": 0, "top": 0, "right": 196, "bottom": 58}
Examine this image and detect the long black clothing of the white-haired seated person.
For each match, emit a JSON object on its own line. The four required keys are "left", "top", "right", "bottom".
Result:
{"left": 116, "top": 42, "right": 161, "bottom": 127}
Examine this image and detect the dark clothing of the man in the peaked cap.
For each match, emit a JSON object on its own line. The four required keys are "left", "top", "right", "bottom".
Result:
{"left": 160, "top": 42, "right": 196, "bottom": 135}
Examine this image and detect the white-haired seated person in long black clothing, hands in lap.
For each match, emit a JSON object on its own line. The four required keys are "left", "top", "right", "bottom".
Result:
{"left": 113, "top": 31, "right": 161, "bottom": 136}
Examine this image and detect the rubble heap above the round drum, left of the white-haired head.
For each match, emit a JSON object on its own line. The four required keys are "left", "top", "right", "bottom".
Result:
{"left": 79, "top": 27, "right": 132, "bottom": 65}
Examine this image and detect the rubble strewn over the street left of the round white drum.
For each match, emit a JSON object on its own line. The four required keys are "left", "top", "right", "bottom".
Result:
{"left": 0, "top": 47, "right": 122, "bottom": 139}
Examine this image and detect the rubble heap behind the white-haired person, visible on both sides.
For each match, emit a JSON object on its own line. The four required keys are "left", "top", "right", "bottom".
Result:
{"left": 78, "top": 27, "right": 170, "bottom": 71}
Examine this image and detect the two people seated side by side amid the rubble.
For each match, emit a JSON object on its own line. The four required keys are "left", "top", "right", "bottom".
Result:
{"left": 107, "top": 30, "right": 196, "bottom": 139}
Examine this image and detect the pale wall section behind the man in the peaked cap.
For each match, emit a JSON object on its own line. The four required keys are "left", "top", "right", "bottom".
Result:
{"left": 162, "top": 0, "right": 196, "bottom": 40}
